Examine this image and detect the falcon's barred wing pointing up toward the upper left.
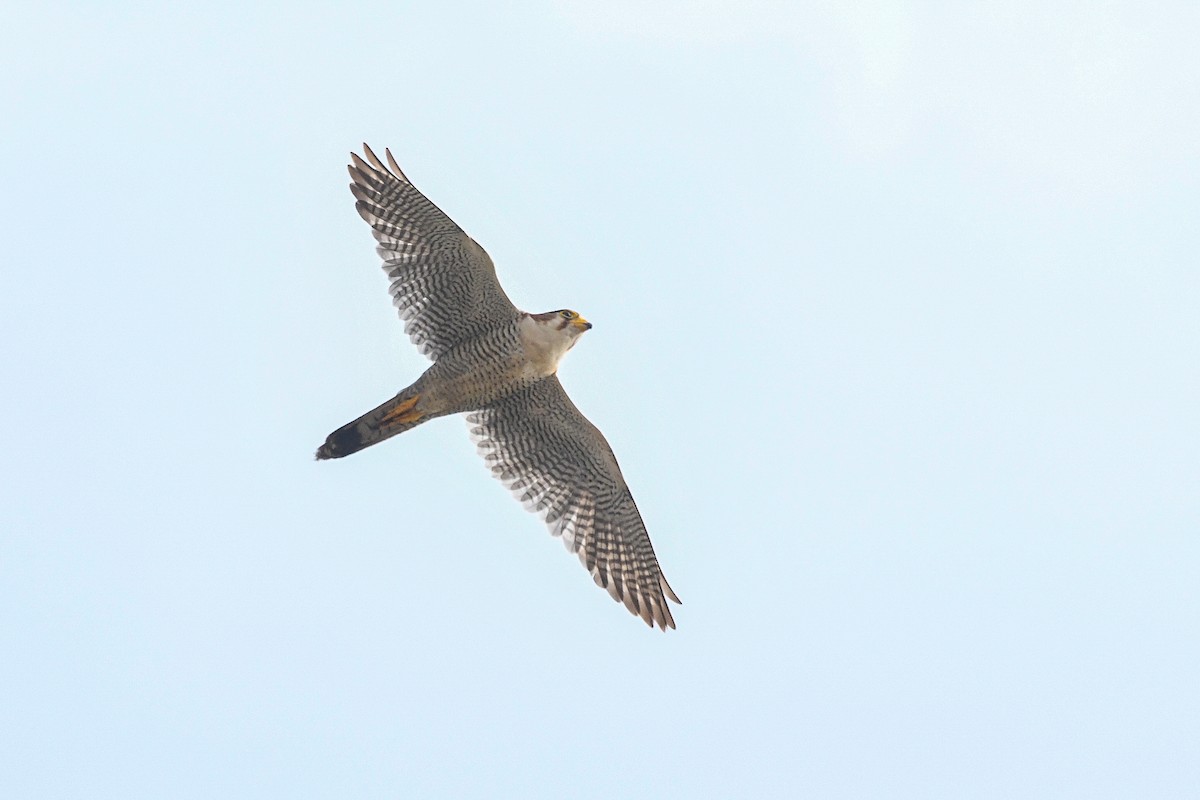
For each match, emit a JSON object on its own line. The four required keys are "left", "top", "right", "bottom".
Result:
{"left": 349, "top": 144, "right": 518, "bottom": 361}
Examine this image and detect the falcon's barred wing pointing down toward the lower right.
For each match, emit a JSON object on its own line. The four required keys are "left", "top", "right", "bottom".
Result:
{"left": 467, "top": 375, "right": 679, "bottom": 630}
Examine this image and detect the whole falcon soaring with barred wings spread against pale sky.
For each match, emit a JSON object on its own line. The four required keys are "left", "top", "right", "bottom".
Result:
{"left": 317, "top": 144, "right": 680, "bottom": 631}
